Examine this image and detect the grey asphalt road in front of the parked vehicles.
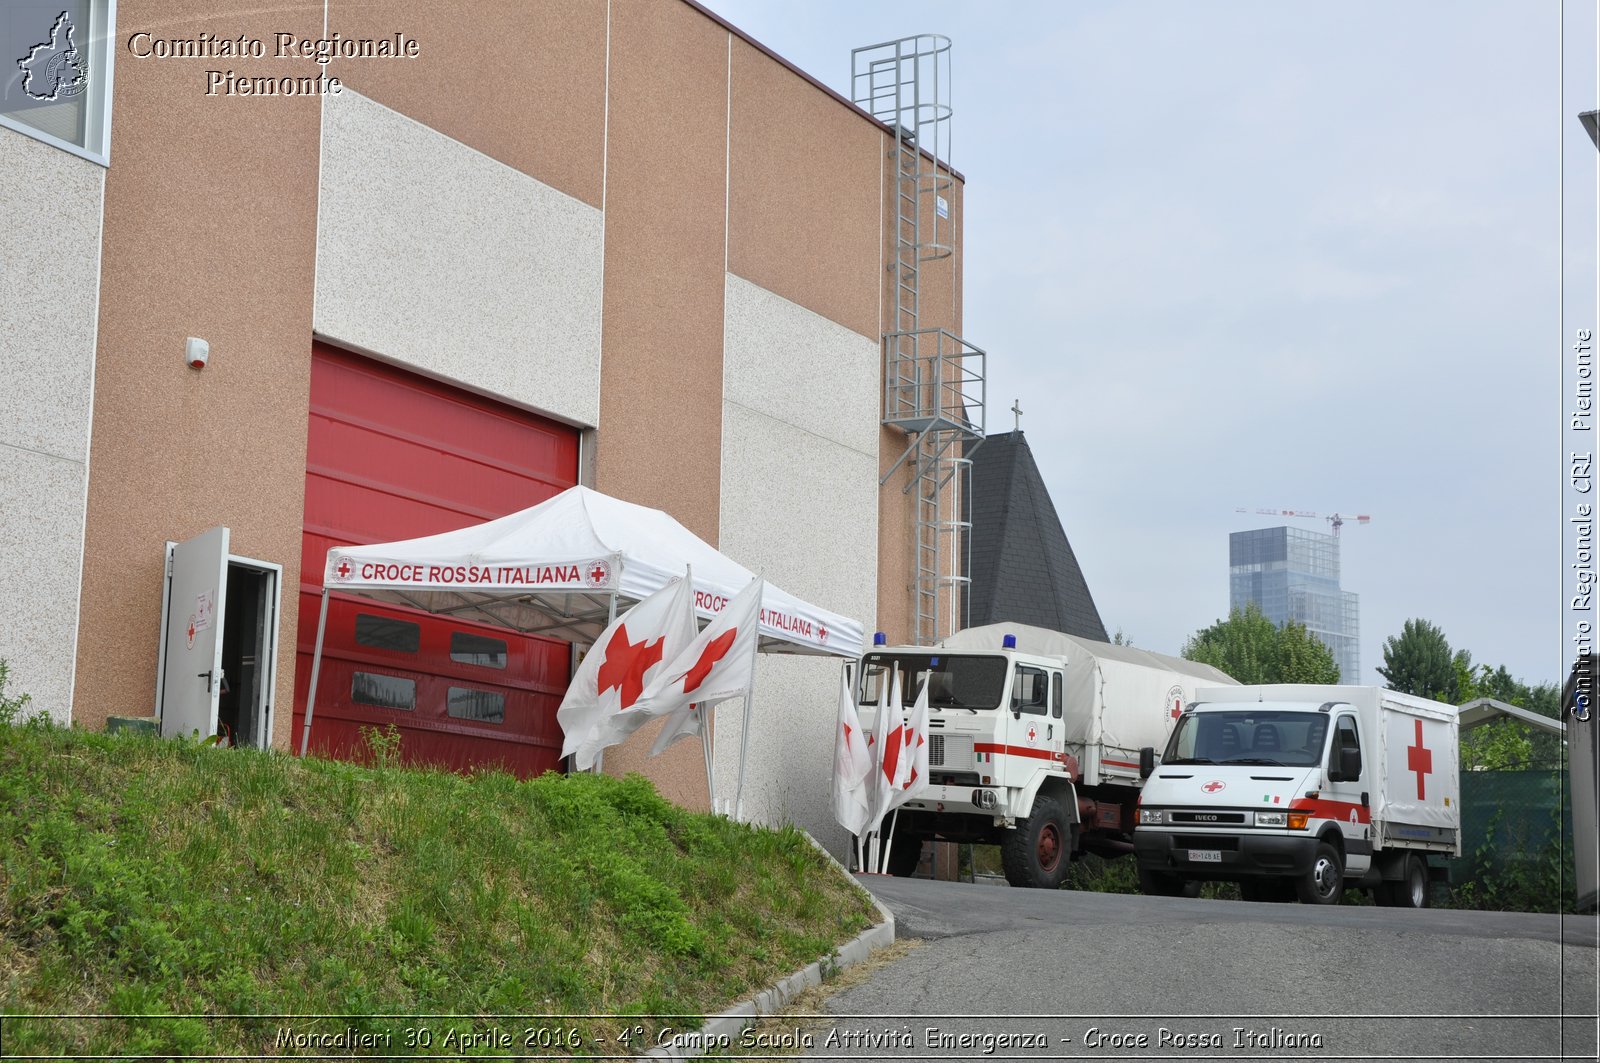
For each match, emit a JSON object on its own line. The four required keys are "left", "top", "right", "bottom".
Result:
{"left": 805, "top": 876, "right": 1597, "bottom": 1060}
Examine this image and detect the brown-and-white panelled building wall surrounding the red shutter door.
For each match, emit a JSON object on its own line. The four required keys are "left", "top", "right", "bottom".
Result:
{"left": 53, "top": 0, "right": 960, "bottom": 851}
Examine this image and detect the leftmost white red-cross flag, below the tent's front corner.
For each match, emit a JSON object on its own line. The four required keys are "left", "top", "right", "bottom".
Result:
{"left": 555, "top": 580, "right": 696, "bottom": 772}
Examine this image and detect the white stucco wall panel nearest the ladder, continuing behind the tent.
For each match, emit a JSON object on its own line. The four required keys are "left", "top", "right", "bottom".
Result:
{"left": 715, "top": 274, "right": 878, "bottom": 853}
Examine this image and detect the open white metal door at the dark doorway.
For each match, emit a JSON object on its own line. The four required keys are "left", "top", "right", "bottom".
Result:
{"left": 162, "top": 528, "right": 227, "bottom": 738}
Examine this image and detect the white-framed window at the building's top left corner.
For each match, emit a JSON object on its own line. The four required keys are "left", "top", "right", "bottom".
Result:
{"left": 0, "top": 0, "right": 116, "bottom": 166}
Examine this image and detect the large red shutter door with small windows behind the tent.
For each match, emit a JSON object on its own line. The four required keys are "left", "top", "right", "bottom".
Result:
{"left": 293, "top": 344, "right": 578, "bottom": 775}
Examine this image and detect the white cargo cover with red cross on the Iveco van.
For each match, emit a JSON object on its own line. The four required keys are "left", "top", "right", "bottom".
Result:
{"left": 1195, "top": 684, "right": 1461, "bottom": 840}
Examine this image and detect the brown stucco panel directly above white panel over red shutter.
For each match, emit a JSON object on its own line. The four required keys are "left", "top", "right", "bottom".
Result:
{"left": 318, "top": 0, "right": 604, "bottom": 207}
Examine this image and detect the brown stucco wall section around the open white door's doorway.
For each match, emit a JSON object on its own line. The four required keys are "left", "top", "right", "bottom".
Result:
{"left": 74, "top": 0, "right": 322, "bottom": 744}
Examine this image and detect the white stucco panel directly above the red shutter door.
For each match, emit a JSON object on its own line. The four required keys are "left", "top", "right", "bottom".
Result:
{"left": 312, "top": 90, "right": 602, "bottom": 424}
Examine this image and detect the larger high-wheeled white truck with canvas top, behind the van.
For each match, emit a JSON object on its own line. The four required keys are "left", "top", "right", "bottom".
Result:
{"left": 856, "top": 624, "right": 1234, "bottom": 889}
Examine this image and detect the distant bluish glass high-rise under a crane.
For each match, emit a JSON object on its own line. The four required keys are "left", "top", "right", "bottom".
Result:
{"left": 1227, "top": 527, "right": 1362, "bottom": 684}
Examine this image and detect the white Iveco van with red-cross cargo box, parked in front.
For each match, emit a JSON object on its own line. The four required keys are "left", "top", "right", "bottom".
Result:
{"left": 1133, "top": 684, "right": 1461, "bottom": 908}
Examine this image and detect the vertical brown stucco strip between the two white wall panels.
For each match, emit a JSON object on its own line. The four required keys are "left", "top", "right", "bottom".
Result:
{"left": 595, "top": 0, "right": 728, "bottom": 807}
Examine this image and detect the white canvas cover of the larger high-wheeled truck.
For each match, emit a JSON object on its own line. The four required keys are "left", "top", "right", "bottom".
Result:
{"left": 941, "top": 624, "right": 1234, "bottom": 771}
